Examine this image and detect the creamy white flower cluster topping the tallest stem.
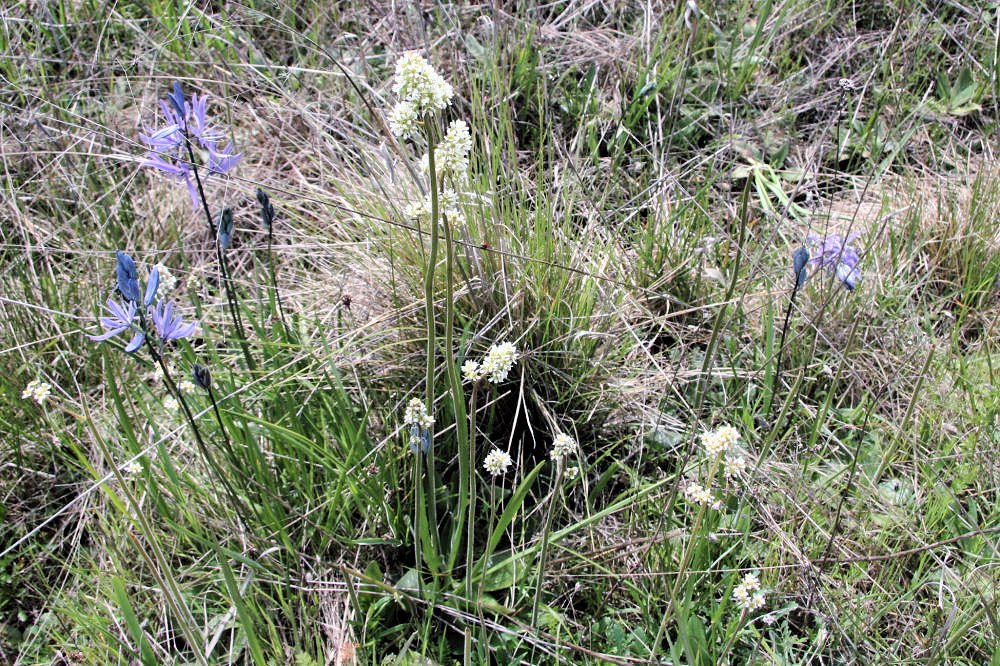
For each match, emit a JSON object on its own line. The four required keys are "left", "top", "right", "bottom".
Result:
{"left": 389, "top": 53, "right": 455, "bottom": 138}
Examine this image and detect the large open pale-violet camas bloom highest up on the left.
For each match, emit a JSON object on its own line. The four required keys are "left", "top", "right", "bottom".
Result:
{"left": 139, "top": 82, "right": 242, "bottom": 209}
